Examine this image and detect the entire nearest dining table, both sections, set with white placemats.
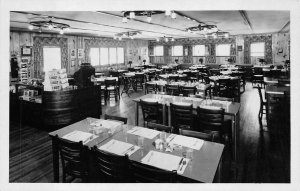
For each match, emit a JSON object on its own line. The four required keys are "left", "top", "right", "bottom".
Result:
{"left": 49, "top": 118, "right": 224, "bottom": 183}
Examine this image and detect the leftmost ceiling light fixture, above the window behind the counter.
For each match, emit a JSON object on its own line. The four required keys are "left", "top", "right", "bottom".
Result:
{"left": 28, "top": 20, "right": 70, "bottom": 34}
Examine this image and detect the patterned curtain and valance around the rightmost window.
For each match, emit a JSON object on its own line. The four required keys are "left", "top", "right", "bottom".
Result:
{"left": 244, "top": 35, "right": 273, "bottom": 64}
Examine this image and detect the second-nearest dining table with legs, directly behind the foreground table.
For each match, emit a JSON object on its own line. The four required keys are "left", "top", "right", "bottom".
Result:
{"left": 133, "top": 94, "right": 241, "bottom": 161}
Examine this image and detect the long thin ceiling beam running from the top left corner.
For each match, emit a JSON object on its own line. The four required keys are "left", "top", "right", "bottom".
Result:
{"left": 11, "top": 11, "right": 190, "bottom": 38}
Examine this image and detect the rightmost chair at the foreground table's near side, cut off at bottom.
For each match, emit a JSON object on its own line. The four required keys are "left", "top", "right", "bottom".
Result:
{"left": 130, "top": 161, "right": 177, "bottom": 183}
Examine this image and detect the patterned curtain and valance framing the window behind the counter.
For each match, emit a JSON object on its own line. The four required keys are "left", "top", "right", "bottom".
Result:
{"left": 32, "top": 37, "right": 68, "bottom": 78}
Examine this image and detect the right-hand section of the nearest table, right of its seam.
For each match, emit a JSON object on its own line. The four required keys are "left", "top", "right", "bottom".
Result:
{"left": 98, "top": 125, "right": 224, "bottom": 183}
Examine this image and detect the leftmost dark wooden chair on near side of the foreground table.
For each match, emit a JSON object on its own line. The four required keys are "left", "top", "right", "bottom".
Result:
{"left": 55, "top": 135, "right": 88, "bottom": 182}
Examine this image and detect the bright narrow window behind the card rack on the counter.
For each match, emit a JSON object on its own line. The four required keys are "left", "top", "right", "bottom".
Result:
{"left": 43, "top": 47, "right": 61, "bottom": 72}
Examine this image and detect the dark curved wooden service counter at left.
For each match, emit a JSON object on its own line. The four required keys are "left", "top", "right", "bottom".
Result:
{"left": 10, "top": 84, "right": 102, "bottom": 130}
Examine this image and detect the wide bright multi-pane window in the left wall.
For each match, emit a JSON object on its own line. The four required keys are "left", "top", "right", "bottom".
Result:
{"left": 90, "top": 47, "right": 124, "bottom": 66}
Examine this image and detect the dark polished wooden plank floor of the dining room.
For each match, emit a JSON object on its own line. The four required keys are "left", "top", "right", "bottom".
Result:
{"left": 9, "top": 83, "right": 290, "bottom": 183}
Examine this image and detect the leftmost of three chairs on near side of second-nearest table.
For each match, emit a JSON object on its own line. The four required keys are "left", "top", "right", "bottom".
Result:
{"left": 140, "top": 99, "right": 162, "bottom": 127}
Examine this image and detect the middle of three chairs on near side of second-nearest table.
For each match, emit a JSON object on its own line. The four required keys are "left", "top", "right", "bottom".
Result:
{"left": 170, "top": 103, "right": 194, "bottom": 133}
